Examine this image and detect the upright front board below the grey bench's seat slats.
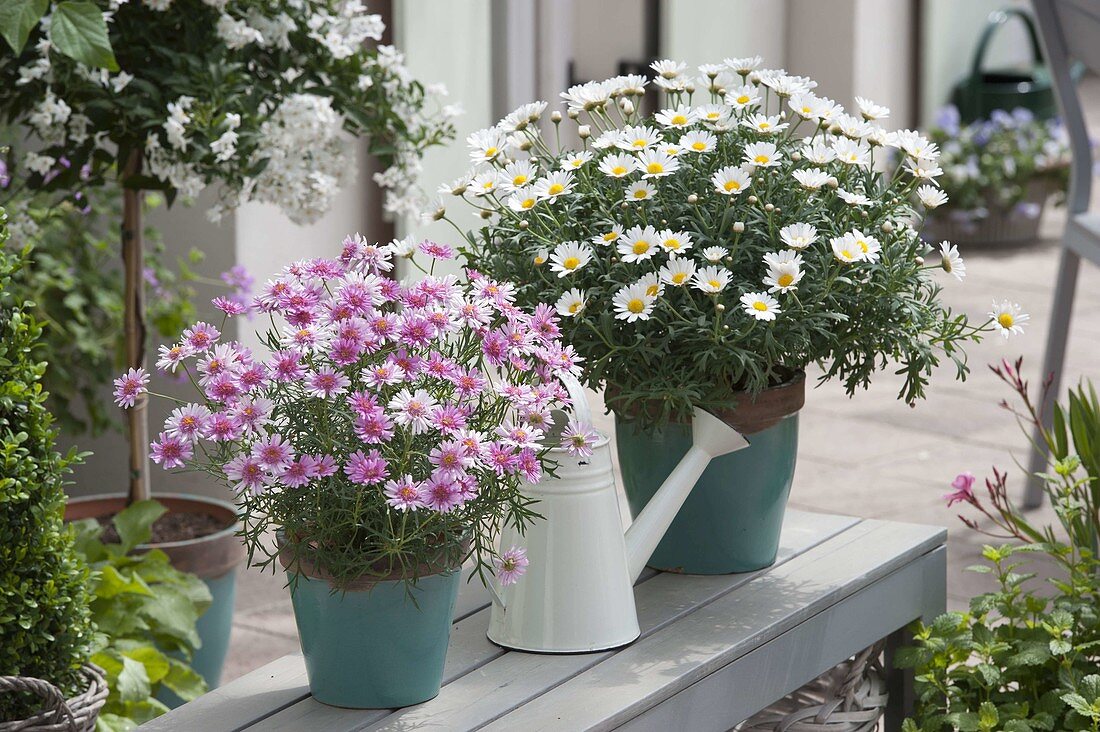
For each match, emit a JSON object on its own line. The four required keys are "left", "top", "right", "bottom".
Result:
{"left": 616, "top": 547, "right": 947, "bottom": 732}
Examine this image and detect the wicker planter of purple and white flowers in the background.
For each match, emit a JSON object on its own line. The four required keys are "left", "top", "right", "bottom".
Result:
{"left": 921, "top": 178, "right": 1057, "bottom": 245}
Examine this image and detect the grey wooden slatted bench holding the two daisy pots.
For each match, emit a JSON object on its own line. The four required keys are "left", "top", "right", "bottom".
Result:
{"left": 142, "top": 511, "right": 947, "bottom": 732}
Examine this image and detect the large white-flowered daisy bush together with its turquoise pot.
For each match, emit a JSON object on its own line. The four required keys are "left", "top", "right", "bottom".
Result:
{"left": 451, "top": 58, "right": 1025, "bottom": 573}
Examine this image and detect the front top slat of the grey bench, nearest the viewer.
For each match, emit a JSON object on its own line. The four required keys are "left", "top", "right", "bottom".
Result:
{"left": 481, "top": 521, "right": 946, "bottom": 732}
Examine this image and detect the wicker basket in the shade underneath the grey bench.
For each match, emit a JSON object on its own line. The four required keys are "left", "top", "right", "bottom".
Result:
{"left": 735, "top": 642, "right": 887, "bottom": 732}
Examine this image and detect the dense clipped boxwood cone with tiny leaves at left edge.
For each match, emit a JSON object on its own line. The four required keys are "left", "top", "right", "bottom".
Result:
{"left": 0, "top": 209, "right": 92, "bottom": 720}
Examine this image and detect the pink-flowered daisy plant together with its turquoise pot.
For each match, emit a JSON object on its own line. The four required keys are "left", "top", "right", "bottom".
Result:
{"left": 116, "top": 237, "right": 575, "bottom": 708}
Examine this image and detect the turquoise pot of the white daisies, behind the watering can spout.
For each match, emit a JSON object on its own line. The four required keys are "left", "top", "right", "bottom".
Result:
{"left": 615, "top": 414, "right": 799, "bottom": 575}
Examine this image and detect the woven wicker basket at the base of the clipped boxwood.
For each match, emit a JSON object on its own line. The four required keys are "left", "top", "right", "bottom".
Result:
{"left": 0, "top": 664, "right": 108, "bottom": 732}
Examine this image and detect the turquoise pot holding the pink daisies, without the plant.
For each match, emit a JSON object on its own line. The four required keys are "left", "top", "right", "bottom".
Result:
{"left": 290, "top": 571, "right": 462, "bottom": 709}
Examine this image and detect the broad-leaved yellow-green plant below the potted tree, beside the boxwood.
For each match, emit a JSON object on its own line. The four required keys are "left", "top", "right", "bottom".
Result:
{"left": 75, "top": 501, "right": 210, "bottom": 732}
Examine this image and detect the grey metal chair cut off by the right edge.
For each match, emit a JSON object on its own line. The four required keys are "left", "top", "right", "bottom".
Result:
{"left": 1024, "top": 0, "right": 1100, "bottom": 509}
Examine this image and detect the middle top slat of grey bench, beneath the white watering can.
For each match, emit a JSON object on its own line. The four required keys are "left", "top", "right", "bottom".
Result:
{"left": 347, "top": 513, "right": 858, "bottom": 731}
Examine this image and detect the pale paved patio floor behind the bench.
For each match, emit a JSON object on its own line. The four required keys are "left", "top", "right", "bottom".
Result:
{"left": 218, "top": 205, "right": 1100, "bottom": 680}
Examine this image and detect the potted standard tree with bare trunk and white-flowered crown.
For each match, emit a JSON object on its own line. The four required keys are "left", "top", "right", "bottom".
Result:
{"left": 0, "top": 0, "right": 451, "bottom": 686}
